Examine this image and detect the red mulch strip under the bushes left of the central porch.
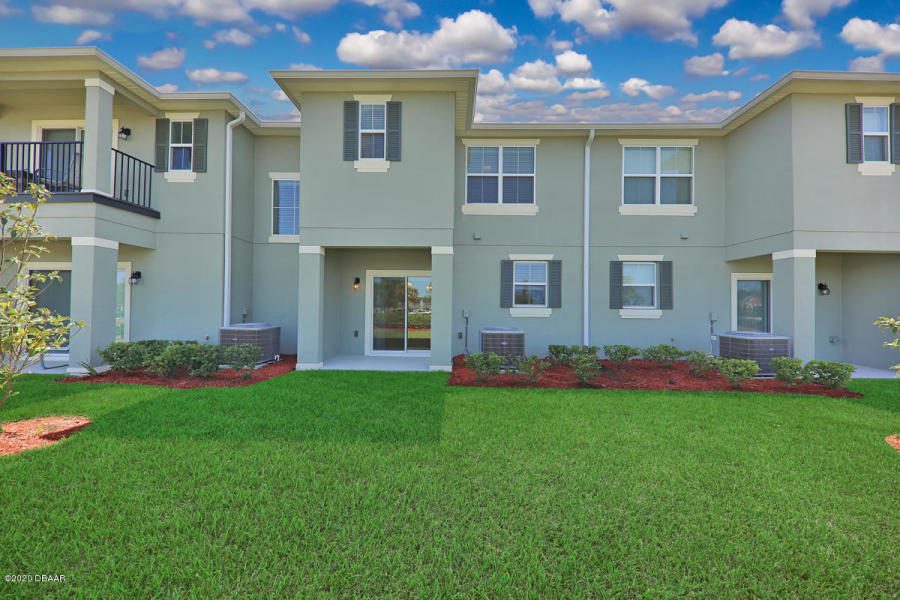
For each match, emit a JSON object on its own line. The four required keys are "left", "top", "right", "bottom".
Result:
{"left": 60, "top": 355, "right": 297, "bottom": 389}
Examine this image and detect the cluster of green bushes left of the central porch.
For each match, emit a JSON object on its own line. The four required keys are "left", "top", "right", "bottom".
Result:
{"left": 100, "top": 340, "right": 260, "bottom": 377}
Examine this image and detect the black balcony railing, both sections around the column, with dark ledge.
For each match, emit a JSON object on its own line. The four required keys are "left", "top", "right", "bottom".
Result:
{"left": 0, "top": 141, "right": 159, "bottom": 219}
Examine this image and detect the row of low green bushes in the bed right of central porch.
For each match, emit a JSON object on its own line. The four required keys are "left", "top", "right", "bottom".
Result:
{"left": 466, "top": 344, "right": 854, "bottom": 387}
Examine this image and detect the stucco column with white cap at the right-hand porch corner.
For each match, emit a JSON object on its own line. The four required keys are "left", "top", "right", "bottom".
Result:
{"left": 772, "top": 250, "right": 817, "bottom": 361}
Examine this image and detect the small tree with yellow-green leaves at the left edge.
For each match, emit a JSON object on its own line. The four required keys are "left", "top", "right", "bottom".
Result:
{"left": 0, "top": 173, "right": 83, "bottom": 406}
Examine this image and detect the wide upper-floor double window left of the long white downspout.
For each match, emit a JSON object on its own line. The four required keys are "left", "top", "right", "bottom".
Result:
{"left": 466, "top": 145, "right": 535, "bottom": 205}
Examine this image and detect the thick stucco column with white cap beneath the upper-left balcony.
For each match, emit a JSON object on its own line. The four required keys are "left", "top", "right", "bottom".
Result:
{"left": 68, "top": 238, "right": 119, "bottom": 374}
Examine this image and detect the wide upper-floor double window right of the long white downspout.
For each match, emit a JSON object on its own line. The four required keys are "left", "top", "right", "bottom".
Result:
{"left": 622, "top": 146, "right": 694, "bottom": 205}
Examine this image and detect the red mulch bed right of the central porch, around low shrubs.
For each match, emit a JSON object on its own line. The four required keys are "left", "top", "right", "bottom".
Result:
{"left": 450, "top": 354, "right": 862, "bottom": 398}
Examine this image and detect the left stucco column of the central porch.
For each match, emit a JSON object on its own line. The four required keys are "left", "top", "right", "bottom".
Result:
{"left": 297, "top": 246, "right": 325, "bottom": 371}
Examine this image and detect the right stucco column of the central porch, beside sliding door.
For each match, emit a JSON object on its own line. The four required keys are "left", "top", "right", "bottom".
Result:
{"left": 430, "top": 246, "right": 453, "bottom": 371}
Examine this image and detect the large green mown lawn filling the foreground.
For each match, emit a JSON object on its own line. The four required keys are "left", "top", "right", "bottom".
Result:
{"left": 0, "top": 372, "right": 900, "bottom": 598}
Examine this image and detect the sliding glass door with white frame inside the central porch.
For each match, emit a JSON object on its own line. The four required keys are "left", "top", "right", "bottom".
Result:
{"left": 371, "top": 274, "right": 431, "bottom": 353}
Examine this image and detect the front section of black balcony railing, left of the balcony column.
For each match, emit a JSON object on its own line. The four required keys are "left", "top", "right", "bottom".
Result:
{"left": 0, "top": 142, "right": 84, "bottom": 193}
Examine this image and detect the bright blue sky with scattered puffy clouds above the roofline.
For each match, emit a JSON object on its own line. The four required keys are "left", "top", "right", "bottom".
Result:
{"left": 0, "top": 0, "right": 900, "bottom": 122}
